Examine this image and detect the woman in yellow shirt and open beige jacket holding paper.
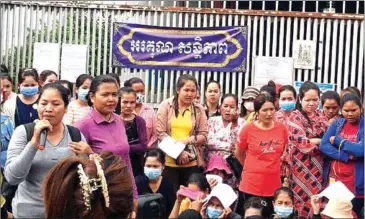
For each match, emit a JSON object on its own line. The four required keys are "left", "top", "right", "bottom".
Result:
{"left": 157, "top": 74, "right": 208, "bottom": 191}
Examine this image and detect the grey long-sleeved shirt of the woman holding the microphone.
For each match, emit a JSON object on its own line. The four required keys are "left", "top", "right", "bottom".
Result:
{"left": 4, "top": 125, "right": 85, "bottom": 218}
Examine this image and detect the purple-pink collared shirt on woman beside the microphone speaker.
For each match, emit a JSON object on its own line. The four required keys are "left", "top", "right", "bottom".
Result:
{"left": 75, "top": 109, "right": 138, "bottom": 199}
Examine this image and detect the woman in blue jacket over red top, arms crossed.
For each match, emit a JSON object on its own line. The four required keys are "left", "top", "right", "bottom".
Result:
{"left": 320, "top": 93, "right": 364, "bottom": 217}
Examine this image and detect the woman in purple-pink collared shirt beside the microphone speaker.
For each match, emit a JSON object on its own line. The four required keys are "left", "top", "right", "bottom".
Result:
{"left": 76, "top": 75, "right": 138, "bottom": 217}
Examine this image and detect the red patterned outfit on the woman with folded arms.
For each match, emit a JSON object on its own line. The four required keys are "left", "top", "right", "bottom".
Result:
{"left": 288, "top": 110, "right": 328, "bottom": 218}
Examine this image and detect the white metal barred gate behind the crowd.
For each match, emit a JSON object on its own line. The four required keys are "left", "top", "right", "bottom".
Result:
{"left": 0, "top": 1, "right": 364, "bottom": 106}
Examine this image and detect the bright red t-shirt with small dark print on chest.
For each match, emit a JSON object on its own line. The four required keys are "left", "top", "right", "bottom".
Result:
{"left": 238, "top": 122, "right": 288, "bottom": 197}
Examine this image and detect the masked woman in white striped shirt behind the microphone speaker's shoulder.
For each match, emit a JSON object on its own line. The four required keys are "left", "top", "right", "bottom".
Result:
{"left": 63, "top": 74, "right": 93, "bottom": 125}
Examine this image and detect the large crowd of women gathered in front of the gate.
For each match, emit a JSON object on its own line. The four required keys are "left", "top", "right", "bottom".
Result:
{"left": 0, "top": 65, "right": 364, "bottom": 219}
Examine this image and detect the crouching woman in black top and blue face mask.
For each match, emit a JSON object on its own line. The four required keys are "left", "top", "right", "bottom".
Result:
{"left": 136, "top": 148, "right": 176, "bottom": 218}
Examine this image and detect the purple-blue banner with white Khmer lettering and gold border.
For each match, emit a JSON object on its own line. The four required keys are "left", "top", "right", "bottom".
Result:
{"left": 112, "top": 22, "right": 247, "bottom": 72}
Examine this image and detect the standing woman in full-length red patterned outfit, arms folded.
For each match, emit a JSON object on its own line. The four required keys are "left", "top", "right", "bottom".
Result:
{"left": 288, "top": 81, "right": 328, "bottom": 218}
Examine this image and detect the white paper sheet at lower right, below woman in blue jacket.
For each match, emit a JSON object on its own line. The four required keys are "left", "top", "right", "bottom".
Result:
{"left": 318, "top": 181, "right": 355, "bottom": 201}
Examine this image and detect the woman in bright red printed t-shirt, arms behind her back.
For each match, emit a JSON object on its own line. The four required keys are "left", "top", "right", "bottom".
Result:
{"left": 236, "top": 94, "right": 288, "bottom": 216}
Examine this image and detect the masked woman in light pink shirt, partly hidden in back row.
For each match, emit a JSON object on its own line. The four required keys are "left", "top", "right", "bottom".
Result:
{"left": 124, "top": 78, "right": 157, "bottom": 147}
